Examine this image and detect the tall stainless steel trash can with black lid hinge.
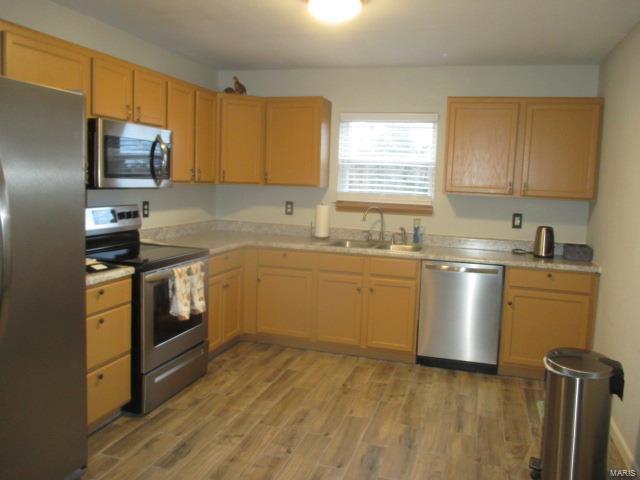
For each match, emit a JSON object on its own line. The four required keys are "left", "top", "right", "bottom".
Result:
{"left": 531, "top": 348, "right": 624, "bottom": 480}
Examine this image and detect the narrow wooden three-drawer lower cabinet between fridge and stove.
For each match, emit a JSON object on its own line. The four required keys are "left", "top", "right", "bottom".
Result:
{"left": 86, "top": 278, "right": 131, "bottom": 431}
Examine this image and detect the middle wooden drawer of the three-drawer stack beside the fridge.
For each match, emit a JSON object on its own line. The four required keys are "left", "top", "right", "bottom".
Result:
{"left": 87, "top": 304, "right": 131, "bottom": 370}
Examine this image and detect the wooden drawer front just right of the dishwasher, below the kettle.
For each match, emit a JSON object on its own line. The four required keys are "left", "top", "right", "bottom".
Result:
{"left": 507, "top": 268, "right": 593, "bottom": 293}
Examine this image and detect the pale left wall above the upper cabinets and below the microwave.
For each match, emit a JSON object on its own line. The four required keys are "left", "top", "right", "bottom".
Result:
{"left": 0, "top": 0, "right": 218, "bottom": 227}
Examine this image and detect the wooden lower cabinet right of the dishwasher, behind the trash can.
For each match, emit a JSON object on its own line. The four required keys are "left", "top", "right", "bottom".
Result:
{"left": 500, "top": 269, "right": 597, "bottom": 377}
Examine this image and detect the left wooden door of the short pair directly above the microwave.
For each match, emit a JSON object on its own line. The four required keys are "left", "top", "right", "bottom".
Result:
{"left": 91, "top": 58, "right": 133, "bottom": 120}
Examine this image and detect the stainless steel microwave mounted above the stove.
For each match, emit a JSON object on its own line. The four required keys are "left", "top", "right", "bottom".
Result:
{"left": 88, "top": 118, "right": 171, "bottom": 188}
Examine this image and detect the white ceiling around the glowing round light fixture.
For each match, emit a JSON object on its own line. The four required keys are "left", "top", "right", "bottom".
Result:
{"left": 53, "top": 0, "right": 640, "bottom": 69}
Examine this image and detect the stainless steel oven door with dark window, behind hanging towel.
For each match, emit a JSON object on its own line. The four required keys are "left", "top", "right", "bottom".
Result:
{"left": 140, "top": 258, "right": 209, "bottom": 373}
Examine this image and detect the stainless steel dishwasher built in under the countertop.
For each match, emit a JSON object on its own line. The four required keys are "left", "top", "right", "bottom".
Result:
{"left": 418, "top": 261, "right": 504, "bottom": 373}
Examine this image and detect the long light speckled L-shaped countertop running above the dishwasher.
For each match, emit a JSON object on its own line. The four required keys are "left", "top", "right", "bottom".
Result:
{"left": 144, "top": 231, "right": 601, "bottom": 275}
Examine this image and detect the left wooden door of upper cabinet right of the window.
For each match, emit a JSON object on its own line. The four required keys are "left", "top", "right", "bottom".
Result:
{"left": 445, "top": 101, "right": 519, "bottom": 195}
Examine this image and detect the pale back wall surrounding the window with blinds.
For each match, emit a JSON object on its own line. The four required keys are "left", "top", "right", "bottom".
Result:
{"left": 216, "top": 66, "right": 598, "bottom": 242}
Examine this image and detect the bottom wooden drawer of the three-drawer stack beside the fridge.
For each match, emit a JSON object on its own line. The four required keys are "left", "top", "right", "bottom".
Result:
{"left": 87, "top": 355, "right": 131, "bottom": 425}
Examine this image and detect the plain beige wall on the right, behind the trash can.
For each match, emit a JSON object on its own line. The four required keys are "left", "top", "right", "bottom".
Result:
{"left": 588, "top": 21, "right": 640, "bottom": 464}
